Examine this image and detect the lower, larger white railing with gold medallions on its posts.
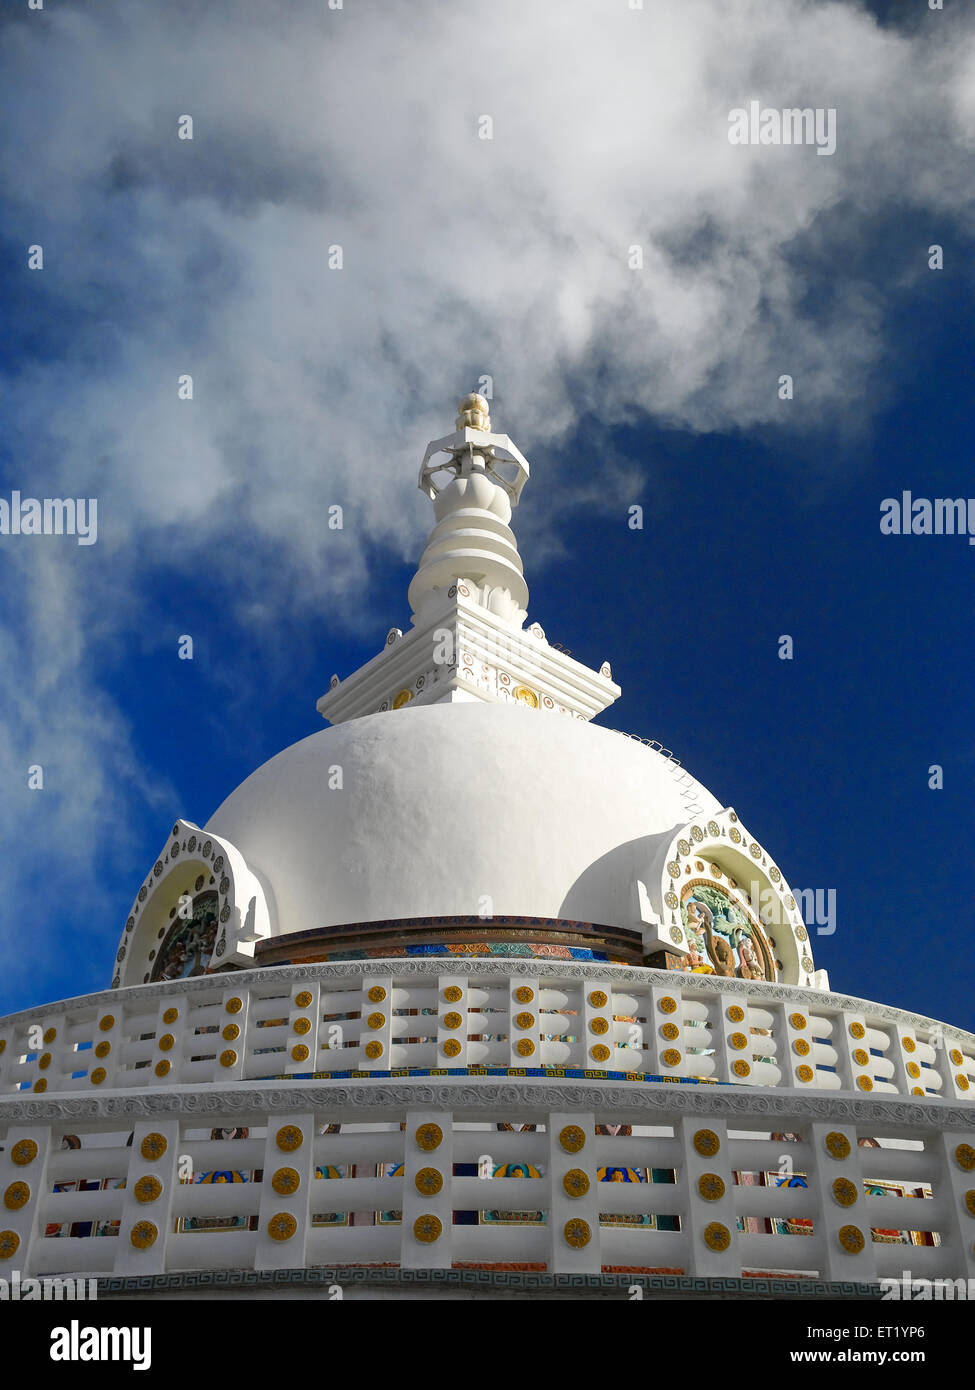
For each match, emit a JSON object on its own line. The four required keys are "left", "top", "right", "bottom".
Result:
{"left": 0, "top": 1079, "right": 975, "bottom": 1283}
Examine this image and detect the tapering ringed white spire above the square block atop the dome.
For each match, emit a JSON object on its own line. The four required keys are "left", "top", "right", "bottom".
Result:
{"left": 409, "top": 392, "right": 529, "bottom": 628}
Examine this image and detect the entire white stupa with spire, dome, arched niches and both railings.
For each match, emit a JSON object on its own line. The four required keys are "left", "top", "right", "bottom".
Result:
{"left": 0, "top": 395, "right": 975, "bottom": 1294}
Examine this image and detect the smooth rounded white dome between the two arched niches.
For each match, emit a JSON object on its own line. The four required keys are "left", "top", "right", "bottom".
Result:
{"left": 206, "top": 701, "right": 720, "bottom": 935}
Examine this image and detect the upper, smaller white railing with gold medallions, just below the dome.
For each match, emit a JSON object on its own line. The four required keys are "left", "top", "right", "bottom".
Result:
{"left": 0, "top": 959, "right": 975, "bottom": 1101}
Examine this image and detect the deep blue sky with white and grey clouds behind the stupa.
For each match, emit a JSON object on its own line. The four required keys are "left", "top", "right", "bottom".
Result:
{"left": 0, "top": 0, "right": 975, "bottom": 1029}
